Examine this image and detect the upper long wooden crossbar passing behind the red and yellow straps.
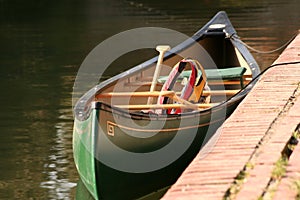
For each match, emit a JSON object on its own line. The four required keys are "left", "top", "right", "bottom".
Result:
{"left": 96, "top": 90, "right": 240, "bottom": 99}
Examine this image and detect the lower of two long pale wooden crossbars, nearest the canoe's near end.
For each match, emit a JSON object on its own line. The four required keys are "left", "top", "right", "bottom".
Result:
{"left": 114, "top": 104, "right": 216, "bottom": 110}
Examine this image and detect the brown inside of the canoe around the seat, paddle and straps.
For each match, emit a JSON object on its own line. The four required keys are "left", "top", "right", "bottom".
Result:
{"left": 94, "top": 32, "right": 252, "bottom": 112}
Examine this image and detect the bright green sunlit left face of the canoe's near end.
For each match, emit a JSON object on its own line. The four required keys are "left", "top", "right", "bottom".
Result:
{"left": 73, "top": 112, "right": 98, "bottom": 199}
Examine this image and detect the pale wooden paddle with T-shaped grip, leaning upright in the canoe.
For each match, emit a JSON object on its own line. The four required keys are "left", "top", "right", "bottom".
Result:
{"left": 147, "top": 45, "right": 171, "bottom": 104}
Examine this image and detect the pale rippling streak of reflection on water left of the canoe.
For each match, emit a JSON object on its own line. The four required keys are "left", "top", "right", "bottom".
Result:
{"left": 40, "top": 69, "right": 77, "bottom": 199}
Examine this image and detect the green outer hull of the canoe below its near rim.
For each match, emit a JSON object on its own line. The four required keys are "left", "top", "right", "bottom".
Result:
{"left": 73, "top": 98, "right": 240, "bottom": 199}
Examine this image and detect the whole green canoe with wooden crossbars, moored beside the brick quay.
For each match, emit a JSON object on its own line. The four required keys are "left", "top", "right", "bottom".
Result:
{"left": 73, "top": 11, "right": 260, "bottom": 199}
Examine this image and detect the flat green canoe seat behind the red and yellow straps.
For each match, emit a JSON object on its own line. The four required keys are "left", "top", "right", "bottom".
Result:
{"left": 158, "top": 67, "right": 246, "bottom": 88}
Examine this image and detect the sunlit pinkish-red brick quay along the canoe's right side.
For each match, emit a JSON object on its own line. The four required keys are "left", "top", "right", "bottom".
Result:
{"left": 162, "top": 34, "right": 300, "bottom": 200}
